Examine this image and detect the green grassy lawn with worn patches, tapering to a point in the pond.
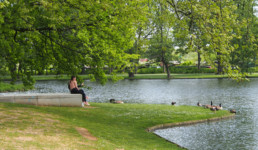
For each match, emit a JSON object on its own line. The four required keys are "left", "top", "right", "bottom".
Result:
{"left": 0, "top": 103, "right": 233, "bottom": 150}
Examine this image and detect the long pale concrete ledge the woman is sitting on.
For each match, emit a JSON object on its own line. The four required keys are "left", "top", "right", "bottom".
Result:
{"left": 0, "top": 93, "right": 82, "bottom": 107}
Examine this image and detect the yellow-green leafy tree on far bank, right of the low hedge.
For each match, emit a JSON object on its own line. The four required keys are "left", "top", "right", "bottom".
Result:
{"left": 167, "top": 0, "right": 242, "bottom": 75}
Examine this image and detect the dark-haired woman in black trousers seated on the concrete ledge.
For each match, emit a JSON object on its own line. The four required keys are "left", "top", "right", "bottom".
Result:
{"left": 70, "top": 76, "right": 90, "bottom": 105}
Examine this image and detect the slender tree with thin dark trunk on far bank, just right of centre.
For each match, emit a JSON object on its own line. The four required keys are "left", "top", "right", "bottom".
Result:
{"left": 147, "top": 0, "right": 175, "bottom": 79}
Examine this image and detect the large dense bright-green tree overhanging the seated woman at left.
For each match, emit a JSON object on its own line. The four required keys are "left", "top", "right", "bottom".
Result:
{"left": 0, "top": 0, "right": 144, "bottom": 85}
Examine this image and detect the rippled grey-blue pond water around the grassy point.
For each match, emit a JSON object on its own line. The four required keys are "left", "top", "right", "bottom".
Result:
{"left": 0, "top": 79, "right": 258, "bottom": 150}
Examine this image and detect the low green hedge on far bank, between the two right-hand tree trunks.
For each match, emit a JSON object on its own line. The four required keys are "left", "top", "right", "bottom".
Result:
{"left": 170, "top": 66, "right": 216, "bottom": 73}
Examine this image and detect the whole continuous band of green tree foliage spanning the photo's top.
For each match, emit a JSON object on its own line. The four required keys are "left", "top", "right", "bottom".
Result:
{"left": 0, "top": 0, "right": 257, "bottom": 86}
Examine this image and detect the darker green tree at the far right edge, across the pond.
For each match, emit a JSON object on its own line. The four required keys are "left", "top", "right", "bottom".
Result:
{"left": 231, "top": 0, "right": 257, "bottom": 72}
